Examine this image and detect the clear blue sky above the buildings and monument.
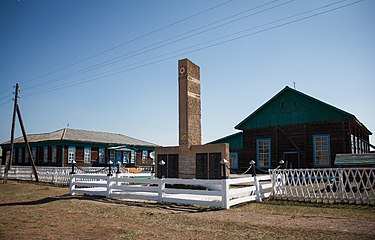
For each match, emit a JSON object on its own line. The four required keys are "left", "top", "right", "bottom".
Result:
{"left": 0, "top": 0, "right": 375, "bottom": 145}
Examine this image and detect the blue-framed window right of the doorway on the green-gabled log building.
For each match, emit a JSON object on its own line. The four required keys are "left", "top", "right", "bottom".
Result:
{"left": 313, "top": 134, "right": 331, "bottom": 167}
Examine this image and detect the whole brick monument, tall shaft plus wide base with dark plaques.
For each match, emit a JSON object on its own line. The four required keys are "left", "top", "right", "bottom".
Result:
{"left": 155, "top": 59, "right": 229, "bottom": 179}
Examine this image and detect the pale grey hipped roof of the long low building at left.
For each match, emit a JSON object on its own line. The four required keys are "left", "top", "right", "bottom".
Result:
{"left": 2, "top": 128, "right": 157, "bottom": 147}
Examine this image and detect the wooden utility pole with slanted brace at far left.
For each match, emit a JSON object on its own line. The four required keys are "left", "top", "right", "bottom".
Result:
{"left": 3, "top": 83, "right": 39, "bottom": 183}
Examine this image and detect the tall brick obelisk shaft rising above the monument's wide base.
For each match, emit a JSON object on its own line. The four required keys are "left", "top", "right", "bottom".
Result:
{"left": 178, "top": 59, "right": 202, "bottom": 148}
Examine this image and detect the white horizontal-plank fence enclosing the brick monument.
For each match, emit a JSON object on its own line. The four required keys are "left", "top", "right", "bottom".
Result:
{"left": 70, "top": 174, "right": 272, "bottom": 209}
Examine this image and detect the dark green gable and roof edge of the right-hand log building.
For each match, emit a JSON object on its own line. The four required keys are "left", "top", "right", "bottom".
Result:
{"left": 235, "top": 86, "right": 371, "bottom": 134}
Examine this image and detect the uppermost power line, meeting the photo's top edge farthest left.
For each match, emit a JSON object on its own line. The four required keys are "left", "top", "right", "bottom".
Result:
{"left": 19, "top": 0, "right": 234, "bottom": 87}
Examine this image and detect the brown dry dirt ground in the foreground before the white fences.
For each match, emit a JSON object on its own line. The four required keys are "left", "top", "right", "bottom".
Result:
{"left": 0, "top": 181, "right": 375, "bottom": 240}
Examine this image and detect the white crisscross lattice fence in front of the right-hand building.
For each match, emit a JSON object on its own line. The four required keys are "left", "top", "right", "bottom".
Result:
{"left": 270, "top": 168, "right": 375, "bottom": 205}
